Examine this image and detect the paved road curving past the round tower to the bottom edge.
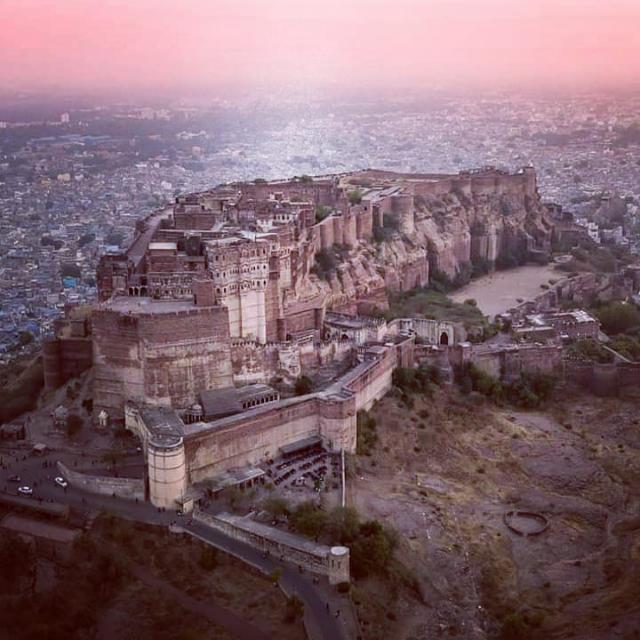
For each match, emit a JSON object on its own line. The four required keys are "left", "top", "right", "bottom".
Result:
{"left": 0, "top": 450, "right": 348, "bottom": 640}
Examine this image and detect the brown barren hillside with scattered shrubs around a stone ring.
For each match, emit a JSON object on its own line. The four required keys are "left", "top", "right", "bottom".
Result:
{"left": 350, "top": 382, "right": 640, "bottom": 640}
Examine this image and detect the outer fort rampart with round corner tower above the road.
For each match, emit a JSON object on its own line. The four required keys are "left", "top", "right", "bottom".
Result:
{"left": 126, "top": 338, "right": 402, "bottom": 506}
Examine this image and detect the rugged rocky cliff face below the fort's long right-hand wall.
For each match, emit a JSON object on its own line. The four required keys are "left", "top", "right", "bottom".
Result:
{"left": 296, "top": 178, "right": 552, "bottom": 312}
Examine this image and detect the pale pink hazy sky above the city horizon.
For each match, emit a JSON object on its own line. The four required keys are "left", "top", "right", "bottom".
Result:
{"left": 0, "top": 0, "right": 640, "bottom": 90}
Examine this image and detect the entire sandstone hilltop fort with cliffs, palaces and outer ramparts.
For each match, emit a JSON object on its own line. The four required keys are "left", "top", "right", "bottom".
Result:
{"left": 45, "top": 168, "right": 553, "bottom": 505}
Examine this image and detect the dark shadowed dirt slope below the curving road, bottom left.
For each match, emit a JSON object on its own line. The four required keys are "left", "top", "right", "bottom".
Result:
{"left": 0, "top": 514, "right": 306, "bottom": 640}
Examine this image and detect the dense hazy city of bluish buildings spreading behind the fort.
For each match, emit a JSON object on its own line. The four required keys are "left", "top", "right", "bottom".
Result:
{"left": 0, "top": 94, "right": 640, "bottom": 362}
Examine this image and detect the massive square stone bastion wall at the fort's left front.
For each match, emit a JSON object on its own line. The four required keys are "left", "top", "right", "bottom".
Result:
{"left": 93, "top": 303, "right": 233, "bottom": 421}
